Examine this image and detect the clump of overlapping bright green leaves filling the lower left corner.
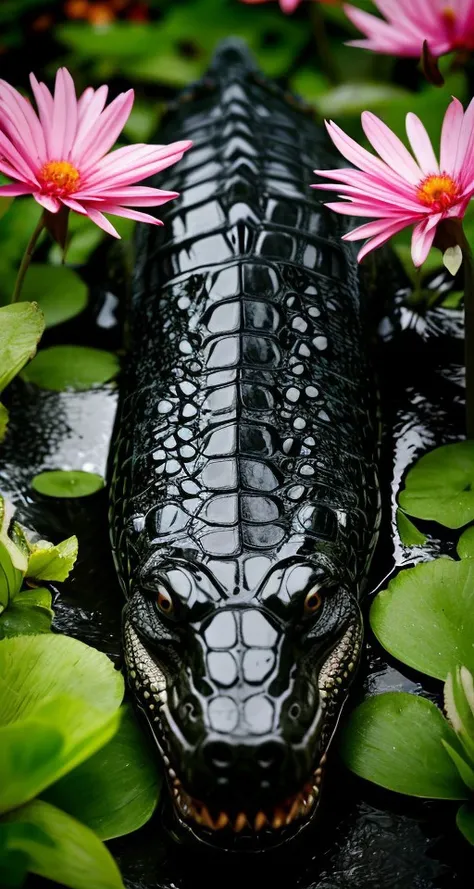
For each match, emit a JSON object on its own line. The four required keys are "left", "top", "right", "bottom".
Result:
{"left": 0, "top": 498, "right": 159, "bottom": 889}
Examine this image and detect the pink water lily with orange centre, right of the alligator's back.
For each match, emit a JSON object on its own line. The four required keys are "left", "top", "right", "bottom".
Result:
{"left": 312, "top": 99, "right": 474, "bottom": 266}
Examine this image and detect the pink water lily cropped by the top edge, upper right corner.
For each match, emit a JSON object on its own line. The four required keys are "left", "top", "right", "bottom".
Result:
{"left": 344, "top": 0, "right": 474, "bottom": 57}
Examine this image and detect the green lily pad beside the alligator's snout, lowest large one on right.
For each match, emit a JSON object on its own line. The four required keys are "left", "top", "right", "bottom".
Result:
{"left": 340, "top": 692, "right": 470, "bottom": 799}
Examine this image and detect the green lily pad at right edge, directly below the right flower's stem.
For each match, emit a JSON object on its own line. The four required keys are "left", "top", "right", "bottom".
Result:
{"left": 399, "top": 441, "right": 474, "bottom": 528}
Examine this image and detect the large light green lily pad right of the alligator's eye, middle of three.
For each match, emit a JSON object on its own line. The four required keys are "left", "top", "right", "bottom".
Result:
{"left": 370, "top": 558, "right": 474, "bottom": 680}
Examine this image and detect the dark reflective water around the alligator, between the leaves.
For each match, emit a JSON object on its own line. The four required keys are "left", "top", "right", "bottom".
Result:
{"left": 0, "top": 253, "right": 474, "bottom": 889}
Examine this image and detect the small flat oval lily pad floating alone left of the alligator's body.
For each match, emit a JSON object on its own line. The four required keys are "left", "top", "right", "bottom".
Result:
{"left": 22, "top": 346, "right": 120, "bottom": 392}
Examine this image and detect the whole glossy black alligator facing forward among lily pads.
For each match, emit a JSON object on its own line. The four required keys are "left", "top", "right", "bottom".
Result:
{"left": 110, "top": 42, "right": 380, "bottom": 850}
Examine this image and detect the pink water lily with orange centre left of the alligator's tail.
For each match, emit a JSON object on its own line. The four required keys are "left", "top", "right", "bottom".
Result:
{"left": 0, "top": 68, "right": 192, "bottom": 238}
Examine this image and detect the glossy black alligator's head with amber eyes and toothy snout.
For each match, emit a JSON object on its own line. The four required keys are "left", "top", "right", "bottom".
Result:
{"left": 124, "top": 554, "right": 362, "bottom": 848}
